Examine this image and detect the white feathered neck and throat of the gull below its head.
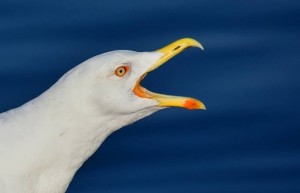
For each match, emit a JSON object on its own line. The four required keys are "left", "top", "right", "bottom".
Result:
{"left": 0, "top": 78, "right": 158, "bottom": 193}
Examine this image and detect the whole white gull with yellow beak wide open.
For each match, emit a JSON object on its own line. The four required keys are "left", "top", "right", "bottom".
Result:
{"left": 0, "top": 38, "right": 205, "bottom": 193}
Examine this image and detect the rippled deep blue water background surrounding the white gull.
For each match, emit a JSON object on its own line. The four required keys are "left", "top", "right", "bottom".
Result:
{"left": 0, "top": 0, "right": 300, "bottom": 193}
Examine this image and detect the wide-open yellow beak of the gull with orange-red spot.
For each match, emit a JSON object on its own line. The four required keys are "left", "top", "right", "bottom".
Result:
{"left": 133, "top": 38, "right": 206, "bottom": 110}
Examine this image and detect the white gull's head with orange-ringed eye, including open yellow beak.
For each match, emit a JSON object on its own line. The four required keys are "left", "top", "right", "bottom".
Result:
{"left": 56, "top": 38, "right": 205, "bottom": 118}
